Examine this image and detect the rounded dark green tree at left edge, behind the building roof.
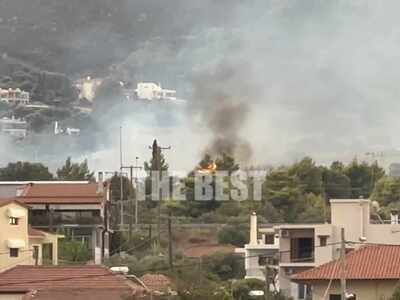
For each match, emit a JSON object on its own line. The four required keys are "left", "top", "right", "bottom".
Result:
{"left": 0, "top": 161, "right": 54, "bottom": 181}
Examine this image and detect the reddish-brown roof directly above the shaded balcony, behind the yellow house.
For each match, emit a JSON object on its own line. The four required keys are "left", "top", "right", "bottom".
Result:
{"left": 18, "top": 183, "right": 103, "bottom": 204}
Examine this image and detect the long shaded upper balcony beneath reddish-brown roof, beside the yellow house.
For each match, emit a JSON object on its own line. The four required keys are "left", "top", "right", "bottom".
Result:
{"left": 29, "top": 211, "right": 103, "bottom": 227}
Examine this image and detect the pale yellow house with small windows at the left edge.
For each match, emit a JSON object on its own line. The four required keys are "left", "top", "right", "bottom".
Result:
{"left": 0, "top": 199, "right": 62, "bottom": 272}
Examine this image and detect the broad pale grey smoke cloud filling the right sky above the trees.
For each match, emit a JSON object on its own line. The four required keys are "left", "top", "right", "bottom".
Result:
{"left": 2, "top": 0, "right": 400, "bottom": 169}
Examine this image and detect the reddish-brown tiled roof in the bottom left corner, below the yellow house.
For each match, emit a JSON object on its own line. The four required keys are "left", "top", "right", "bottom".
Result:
{"left": 0, "top": 265, "right": 142, "bottom": 299}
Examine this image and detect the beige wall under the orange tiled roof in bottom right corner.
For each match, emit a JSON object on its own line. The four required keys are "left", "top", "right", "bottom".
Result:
{"left": 313, "top": 280, "right": 397, "bottom": 300}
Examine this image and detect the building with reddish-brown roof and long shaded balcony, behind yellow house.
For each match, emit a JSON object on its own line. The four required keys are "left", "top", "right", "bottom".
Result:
{"left": 9, "top": 180, "right": 109, "bottom": 264}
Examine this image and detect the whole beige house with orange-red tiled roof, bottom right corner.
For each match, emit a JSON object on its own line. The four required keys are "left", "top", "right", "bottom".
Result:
{"left": 292, "top": 245, "right": 400, "bottom": 300}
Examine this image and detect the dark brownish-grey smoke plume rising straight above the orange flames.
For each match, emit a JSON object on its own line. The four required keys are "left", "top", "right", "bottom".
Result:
{"left": 188, "top": 61, "right": 255, "bottom": 162}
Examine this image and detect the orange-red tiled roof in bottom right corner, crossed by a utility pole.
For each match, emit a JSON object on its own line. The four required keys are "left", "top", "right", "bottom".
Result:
{"left": 292, "top": 245, "right": 400, "bottom": 281}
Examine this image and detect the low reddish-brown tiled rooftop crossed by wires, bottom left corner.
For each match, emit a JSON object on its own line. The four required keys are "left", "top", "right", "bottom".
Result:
{"left": 0, "top": 265, "right": 145, "bottom": 300}
